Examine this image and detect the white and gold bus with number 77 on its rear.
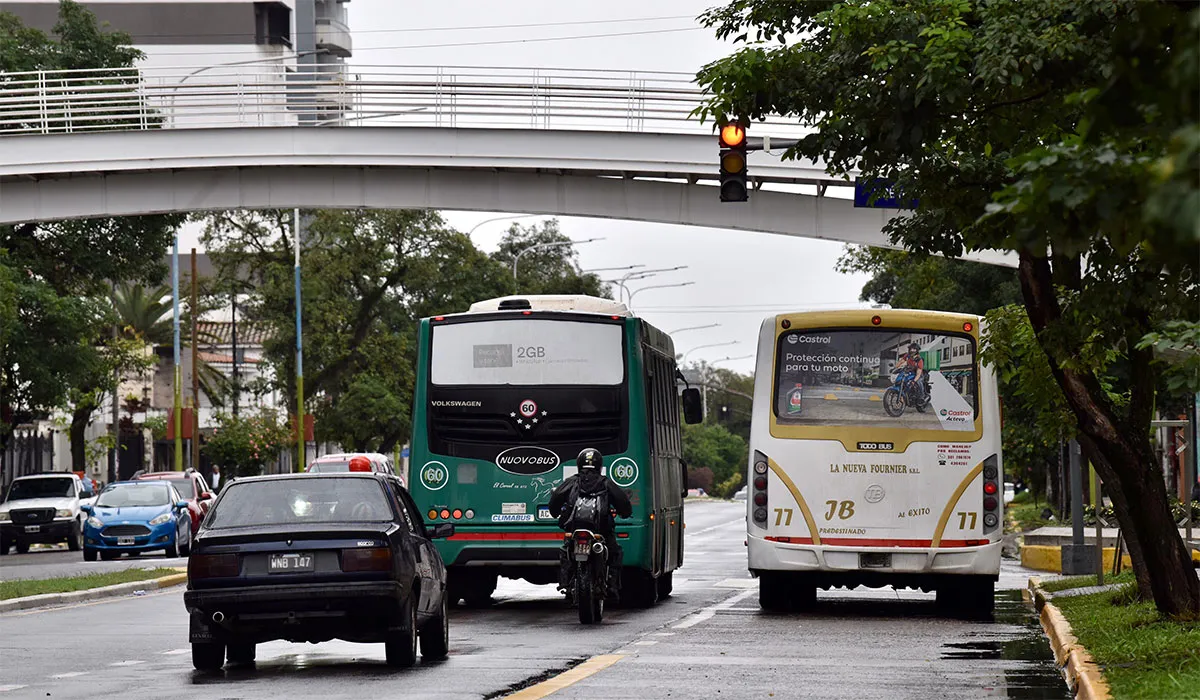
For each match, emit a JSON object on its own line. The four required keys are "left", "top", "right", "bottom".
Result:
{"left": 746, "top": 309, "right": 1003, "bottom": 615}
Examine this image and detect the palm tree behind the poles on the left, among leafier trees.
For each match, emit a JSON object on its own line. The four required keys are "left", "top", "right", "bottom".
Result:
{"left": 113, "top": 282, "right": 229, "bottom": 406}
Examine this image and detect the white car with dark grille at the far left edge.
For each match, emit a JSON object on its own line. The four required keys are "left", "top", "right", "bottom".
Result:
{"left": 0, "top": 472, "right": 96, "bottom": 555}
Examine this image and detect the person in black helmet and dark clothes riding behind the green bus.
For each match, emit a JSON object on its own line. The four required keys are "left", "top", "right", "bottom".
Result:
{"left": 550, "top": 448, "right": 634, "bottom": 598}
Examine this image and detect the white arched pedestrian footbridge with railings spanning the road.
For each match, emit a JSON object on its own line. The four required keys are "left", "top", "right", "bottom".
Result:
{"left": 0, "top": 65, "right": 1009, "bottom": 264}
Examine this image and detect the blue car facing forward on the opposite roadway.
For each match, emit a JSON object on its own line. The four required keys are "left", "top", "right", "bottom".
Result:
{"left": 83, "top": 481, "right": 192, "bottom": 562}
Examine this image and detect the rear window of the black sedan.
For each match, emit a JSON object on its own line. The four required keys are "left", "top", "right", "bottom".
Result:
{"left": 208, "top": 477, "right": 394, "bottom": 530}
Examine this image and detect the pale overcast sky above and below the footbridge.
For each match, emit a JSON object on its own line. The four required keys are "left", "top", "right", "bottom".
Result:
{"left": 187, "top": 0, "right": 865, "bottom": 372}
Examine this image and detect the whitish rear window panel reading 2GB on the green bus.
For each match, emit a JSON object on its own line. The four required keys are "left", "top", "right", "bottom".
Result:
{"left": 430, "top": 318, "right": 625, "bottom": 387}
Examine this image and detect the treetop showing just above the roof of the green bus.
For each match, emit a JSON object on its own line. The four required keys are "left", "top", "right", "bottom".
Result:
{"left": 492, "top": 219, "right": 611, "bottom": 298}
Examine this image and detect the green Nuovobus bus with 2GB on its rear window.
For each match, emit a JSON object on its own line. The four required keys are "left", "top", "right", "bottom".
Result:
{"left": 408, "top": 295, "right": 701, "bottom": 606}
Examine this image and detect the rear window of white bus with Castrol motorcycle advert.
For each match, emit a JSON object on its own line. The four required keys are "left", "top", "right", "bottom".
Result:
{"left": 775, "top": 328, "right": 978, "bottom": 431}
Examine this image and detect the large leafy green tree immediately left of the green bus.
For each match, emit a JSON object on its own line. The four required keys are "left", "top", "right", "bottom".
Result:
{"left": 204, "top": 210, "right": 510, "bottom": 451}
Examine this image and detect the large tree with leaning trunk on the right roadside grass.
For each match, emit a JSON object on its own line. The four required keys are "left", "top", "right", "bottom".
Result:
{"left": 698, "top": 0, "right": 1200, "bottom": 618}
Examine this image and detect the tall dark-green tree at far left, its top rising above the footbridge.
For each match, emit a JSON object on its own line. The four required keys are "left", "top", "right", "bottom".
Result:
{"left": 0, "top": 0, "right": 182, "bottom": 461}
